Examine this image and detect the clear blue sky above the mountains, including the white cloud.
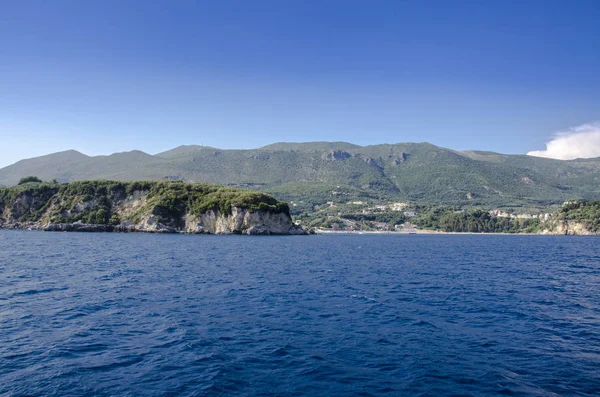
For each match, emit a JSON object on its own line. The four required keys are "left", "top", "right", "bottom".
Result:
{"left": 0, "top": 0, "right": 600, "bottom": 166}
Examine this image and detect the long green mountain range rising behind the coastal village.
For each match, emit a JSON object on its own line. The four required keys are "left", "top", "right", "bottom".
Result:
{"left": 0, "top": 142, "right": 600, "bottom": 212}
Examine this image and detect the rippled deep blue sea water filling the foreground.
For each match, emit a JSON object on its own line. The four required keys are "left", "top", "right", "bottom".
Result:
{"left": 0, "top": 231, "right": 600, "bottom": 396}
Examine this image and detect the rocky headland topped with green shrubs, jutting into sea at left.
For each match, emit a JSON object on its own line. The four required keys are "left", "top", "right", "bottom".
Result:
{"left": 0, "top": 181, "right": 305, "bottom": 234}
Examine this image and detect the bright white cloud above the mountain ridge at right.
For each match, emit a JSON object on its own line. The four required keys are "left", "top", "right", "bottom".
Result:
{"left": 527, "top": 123, "right": 600, "bottom": 160}
